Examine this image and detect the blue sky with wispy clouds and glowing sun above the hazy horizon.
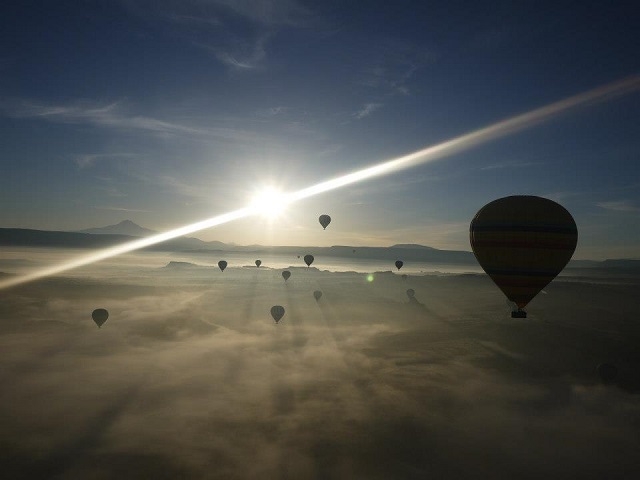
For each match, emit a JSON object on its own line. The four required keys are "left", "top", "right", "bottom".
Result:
{"left": 0, "top": 0, "right": 640, "bottom": 259}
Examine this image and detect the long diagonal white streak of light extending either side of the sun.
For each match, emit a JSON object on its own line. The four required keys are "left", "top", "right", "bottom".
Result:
{"left": 0, "top": 75, "right": 640, "bottom": 289}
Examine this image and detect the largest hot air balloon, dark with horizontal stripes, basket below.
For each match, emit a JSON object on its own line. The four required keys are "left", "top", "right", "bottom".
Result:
{"left": 469, "top": 195, "right": 578, "bottom": 318}
